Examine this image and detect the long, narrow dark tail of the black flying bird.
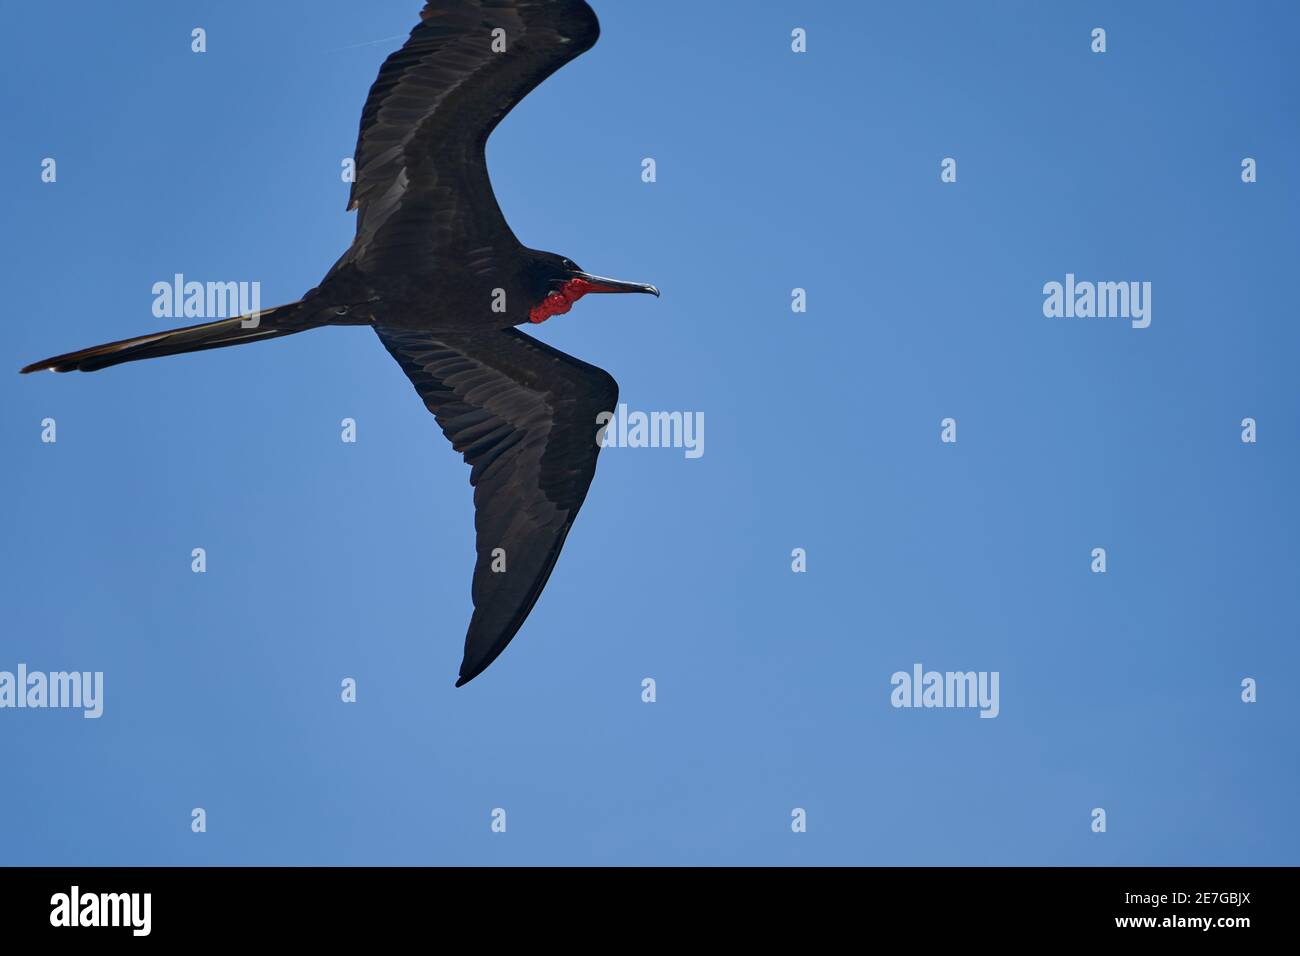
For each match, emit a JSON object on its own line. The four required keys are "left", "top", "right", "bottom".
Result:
{"left": 22, "top": 302, "right": 315, "bottom": 375}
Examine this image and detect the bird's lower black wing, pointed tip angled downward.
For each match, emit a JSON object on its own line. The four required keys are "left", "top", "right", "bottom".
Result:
{"left": 376, "top": 328, "right": 619, "bottom": 687}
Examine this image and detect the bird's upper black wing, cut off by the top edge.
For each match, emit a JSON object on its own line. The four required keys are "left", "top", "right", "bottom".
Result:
{"left": 347, "top": 0, "right": 601, "bottom": 274}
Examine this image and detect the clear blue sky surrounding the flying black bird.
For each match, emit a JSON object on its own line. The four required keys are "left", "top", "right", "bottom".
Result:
{"left": 0, "top": 0, "right": 1300, "bottom": 864}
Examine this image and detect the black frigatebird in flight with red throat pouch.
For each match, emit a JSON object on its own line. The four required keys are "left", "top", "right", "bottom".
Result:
{"left": 22, "top": 0, "right": 659, "bottom": 687}
